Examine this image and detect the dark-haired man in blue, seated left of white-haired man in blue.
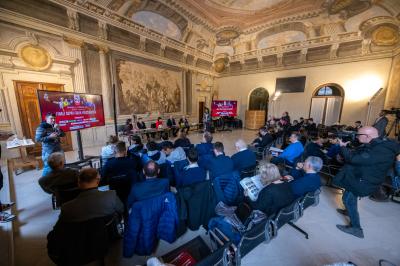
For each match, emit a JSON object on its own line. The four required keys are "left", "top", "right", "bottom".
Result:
{"left": 208, "top": 141, "right": 234, "bottom": 179}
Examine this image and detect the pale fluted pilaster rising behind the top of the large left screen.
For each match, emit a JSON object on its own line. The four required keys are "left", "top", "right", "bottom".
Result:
{"left": 64, "top": 37, "right": 87, "bottom": 93}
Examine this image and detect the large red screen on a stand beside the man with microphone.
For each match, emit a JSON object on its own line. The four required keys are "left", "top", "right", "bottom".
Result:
{"left": 37, "top": 90, "right": 105, "bottom": 132}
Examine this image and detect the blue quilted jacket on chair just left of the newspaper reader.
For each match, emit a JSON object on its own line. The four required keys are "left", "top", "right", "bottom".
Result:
{"left": 212, "top": 171, "right": 243, "bottom": 206}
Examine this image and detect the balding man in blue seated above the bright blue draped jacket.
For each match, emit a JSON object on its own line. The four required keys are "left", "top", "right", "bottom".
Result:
{"left": 127, "top": 161, "right": 169, "bottom": 209}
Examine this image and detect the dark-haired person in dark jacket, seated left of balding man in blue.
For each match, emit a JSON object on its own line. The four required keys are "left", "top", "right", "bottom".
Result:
{"left": 102, "top": 141, "right": 138, "bottom": 184}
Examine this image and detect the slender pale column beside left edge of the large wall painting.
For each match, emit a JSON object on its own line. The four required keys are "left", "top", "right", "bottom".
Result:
{"left": 98, "top": 46, "right": 112, "bottom": 121}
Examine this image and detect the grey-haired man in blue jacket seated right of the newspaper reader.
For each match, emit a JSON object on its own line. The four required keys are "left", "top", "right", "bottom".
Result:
{"left": 290, "top": 156, "right": 322, "bottom": 198}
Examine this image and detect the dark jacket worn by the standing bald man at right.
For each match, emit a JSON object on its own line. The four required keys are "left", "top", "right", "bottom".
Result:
{"left": 333, "top": 138, "right": 400, "bottom": 197}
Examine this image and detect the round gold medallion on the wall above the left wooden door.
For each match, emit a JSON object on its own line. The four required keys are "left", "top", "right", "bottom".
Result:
{"left": 18, "top": 44, "right": 52, "bottom": 71}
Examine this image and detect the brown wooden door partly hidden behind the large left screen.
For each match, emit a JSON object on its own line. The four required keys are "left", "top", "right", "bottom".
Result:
{"left": 15, "top": 81, "right": 72, "bottom": 156}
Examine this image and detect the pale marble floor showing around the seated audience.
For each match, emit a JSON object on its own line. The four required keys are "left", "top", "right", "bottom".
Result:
{"left": 0, "top": 130, "right": 400, "bottom": 266}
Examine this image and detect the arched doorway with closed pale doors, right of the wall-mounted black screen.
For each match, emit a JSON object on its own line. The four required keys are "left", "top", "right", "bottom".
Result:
{"left": 309, "top": 83, "right": 344, "bottom": 126}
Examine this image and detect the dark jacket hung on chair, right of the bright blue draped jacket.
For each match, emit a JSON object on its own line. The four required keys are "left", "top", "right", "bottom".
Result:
{"left": 177, "top": 180, "right": 216, "bottom": 230}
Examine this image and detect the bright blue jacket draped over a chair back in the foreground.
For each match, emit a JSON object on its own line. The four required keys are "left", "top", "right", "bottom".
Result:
{"left": 123, "top": 192, "right": 179, "bottom": 258}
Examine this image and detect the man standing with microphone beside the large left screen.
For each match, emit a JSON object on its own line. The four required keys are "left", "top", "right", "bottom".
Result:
{"left": 35, "top": 113, "right": 65, "bottom": 176}
